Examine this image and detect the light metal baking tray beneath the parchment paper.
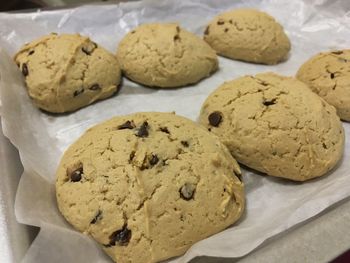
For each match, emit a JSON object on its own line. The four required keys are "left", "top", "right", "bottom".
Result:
{"left": 0, "top": 1, "right": 350, "bottom": 262}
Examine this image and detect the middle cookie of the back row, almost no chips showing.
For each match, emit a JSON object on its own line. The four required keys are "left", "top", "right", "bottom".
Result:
{"left": 117, "top": 23, "right": 218, "bottom": 88}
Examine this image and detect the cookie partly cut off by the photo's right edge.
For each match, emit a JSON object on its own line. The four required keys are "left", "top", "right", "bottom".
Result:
{"left": 296, "top": 49, "right": 350, "bottom": 121}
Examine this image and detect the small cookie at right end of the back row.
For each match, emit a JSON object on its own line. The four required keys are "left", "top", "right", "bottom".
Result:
{"left": 204, "top": 9, "right": 291, "bottom": 64}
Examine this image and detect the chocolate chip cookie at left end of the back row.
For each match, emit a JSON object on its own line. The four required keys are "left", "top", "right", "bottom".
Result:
{"left": 14, "top": 34, "right": 121, "bottom": 113}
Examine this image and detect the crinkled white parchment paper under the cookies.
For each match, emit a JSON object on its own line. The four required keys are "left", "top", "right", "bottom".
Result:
{"left": 0, "top": 0, "right": 350, "bottom": 263}
